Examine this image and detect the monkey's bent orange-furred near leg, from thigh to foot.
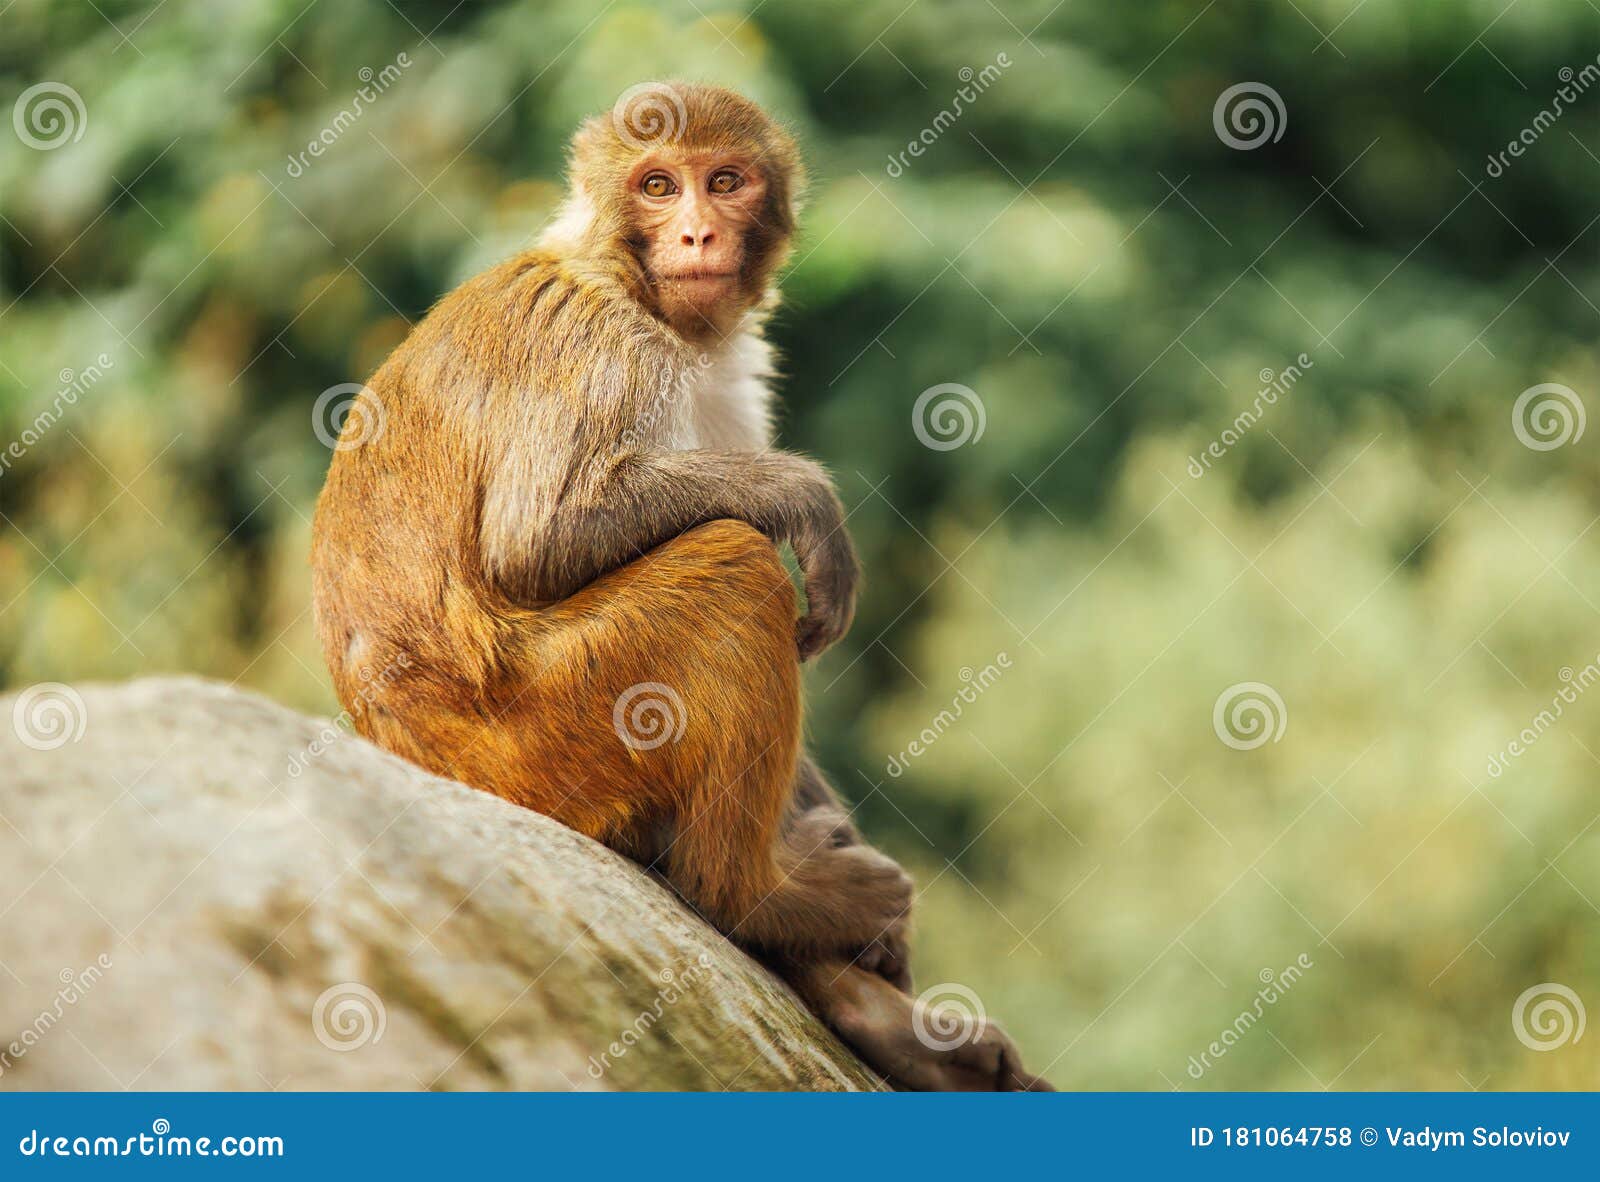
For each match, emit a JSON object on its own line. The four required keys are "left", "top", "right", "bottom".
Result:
{"left": 409, "top": 520, "right": 912, "bottom": 958}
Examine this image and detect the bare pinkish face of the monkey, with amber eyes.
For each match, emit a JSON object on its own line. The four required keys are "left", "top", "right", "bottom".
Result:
{"left": 629, "top": 152, "right": 766, "bottom": 337}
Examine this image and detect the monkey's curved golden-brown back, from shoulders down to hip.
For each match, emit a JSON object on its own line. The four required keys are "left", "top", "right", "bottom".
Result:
{"left": 312, "top": 251, "right": 611, "bottom": 684}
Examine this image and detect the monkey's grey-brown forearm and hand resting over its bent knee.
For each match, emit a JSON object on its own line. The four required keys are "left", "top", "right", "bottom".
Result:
{"left": 533, "top": 451, "right": 859, "bottom": 661}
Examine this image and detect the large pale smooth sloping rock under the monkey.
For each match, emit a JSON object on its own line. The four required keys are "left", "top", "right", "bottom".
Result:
{"left": 0, "top": 678, "right": 880, "bottom": 1089}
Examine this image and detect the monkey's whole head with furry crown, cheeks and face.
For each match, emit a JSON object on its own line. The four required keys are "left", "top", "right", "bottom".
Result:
{"left": 546, "top": 82, "right": 803, "bottom": 341}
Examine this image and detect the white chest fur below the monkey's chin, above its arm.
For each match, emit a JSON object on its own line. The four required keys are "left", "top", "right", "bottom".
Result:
{"left": 658, "top": 333, "right": 773, "bottom": 451}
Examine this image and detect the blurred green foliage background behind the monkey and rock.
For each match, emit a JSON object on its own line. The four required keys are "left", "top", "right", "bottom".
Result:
{"left": 0, "top": 0, "right": 1600, "bottom": 1089}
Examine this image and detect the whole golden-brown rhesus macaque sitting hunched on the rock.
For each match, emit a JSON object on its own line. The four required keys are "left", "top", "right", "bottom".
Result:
{"left": 312, "top": 83, "right": 1048, "bottom": 1089}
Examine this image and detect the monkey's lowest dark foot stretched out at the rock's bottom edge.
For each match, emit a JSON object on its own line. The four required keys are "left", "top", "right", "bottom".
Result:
{"left": 782, "top": 961, "right": 1054, "bottom": 1092}
